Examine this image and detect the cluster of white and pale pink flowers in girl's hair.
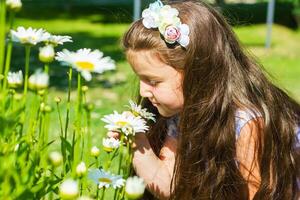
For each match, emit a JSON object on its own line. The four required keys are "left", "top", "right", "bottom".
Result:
{"left": 142, "top": 0, "right": 190, "bottom": 47}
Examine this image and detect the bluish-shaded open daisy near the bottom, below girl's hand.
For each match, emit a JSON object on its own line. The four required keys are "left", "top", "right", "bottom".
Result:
{"left": 88, "top": 169, "right": 125, "bottom": 189}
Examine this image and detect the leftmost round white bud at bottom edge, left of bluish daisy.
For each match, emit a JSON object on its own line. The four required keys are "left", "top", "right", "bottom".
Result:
{"left": 59, "top": 179, "right": 79, "bottom": 199}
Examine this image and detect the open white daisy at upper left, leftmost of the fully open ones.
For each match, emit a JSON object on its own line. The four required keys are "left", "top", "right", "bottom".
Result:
{"left": 11, "top": 26, "right": 47, "bottom": 45}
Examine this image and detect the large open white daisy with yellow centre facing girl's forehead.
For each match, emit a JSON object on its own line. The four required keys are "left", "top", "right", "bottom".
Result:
{"left": 55, "top": 49, "right": 116, "bottom": 81}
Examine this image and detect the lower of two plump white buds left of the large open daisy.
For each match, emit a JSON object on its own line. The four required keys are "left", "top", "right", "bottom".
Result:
{"left": 28, "top": 70, "right": 49, "bottom": 90}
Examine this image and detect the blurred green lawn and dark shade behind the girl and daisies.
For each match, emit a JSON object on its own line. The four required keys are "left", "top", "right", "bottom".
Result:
{"left": 8, "top": 0, "right": 300, "bottom": 143}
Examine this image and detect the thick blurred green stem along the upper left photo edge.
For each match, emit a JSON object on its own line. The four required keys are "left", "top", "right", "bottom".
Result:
{"left": 0, "top": 0, "right": 6, "bottom": 76}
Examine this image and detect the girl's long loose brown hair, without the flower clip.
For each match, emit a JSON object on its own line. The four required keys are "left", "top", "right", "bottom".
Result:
{"left": 123, "top": 1, "right": 300, "bottom": 200}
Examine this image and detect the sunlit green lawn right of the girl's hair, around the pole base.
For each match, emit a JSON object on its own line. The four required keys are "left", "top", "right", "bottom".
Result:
{"left": 235, "top": 25, "right": 300, "bottom": 101}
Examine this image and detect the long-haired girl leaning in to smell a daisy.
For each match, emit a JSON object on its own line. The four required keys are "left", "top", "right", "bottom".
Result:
{"left": 119, "top": 1, "right": 300, "bottom": 200}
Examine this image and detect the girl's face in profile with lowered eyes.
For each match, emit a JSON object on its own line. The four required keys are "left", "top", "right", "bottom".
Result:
{"left": 127, "top": 50, "right": 183, "bottom": 117}
